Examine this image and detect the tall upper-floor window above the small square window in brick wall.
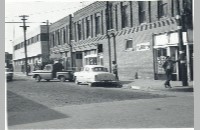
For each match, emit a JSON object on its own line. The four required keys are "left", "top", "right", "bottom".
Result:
{"left": 122, "top": 5, "right": 128, "bottom": 28}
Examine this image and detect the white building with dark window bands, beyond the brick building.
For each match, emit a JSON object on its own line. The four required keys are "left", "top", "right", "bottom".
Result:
{"left": 13, "top": 25, "right": 49, "bottom": 72}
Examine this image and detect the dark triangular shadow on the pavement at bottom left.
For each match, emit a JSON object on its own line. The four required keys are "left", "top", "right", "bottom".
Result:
{"left": 7, "top": 91, "right": 69, "bottom": 126}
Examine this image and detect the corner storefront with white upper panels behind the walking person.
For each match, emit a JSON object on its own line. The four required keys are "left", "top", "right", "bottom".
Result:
{"left": 153, "top": 32, "right": 187, "bottom": 80}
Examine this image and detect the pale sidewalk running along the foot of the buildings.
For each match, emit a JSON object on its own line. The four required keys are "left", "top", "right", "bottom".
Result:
{"left": 14, "top": 72, "right": 193, "bottom": 92}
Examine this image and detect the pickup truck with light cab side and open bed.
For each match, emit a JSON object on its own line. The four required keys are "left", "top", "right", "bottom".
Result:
{"left": 32, "top": 64, "right": 74, "bottom": 82}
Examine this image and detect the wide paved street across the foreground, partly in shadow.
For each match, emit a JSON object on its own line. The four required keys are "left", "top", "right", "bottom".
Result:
{"left": 7, "top": 77, "right": 194, "bottom": 129}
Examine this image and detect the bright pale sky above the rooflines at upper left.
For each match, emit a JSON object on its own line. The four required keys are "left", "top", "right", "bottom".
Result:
{"left": 5, "top": 0, "right": 94, "bottom": 53}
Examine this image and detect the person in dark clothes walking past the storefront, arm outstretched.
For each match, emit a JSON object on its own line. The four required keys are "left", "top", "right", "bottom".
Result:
{"left": 162, "top": 56, "right": 179, "bottom": 88}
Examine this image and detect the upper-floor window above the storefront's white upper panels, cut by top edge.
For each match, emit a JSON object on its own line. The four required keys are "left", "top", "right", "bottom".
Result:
{"left": 158, "top": 0, "right": 169, "bottom": 18}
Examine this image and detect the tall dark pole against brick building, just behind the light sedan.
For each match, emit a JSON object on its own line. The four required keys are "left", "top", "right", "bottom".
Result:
{"left": 106, "top": 1, "right": 112, "bottom": 72}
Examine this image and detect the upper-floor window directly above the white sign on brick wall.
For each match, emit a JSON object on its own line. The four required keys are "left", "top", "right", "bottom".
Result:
{"left": 138, "top": 1, "right": 146, "bottom": 24}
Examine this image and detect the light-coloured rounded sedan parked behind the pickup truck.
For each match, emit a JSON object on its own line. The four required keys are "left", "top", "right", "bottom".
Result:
{"left": 74, "top": 65, "right": 117, "bottom": 86}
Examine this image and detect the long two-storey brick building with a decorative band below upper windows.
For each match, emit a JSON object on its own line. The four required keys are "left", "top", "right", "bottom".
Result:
{"left": 50, "top": 0, "right": 193, "bottom": 80}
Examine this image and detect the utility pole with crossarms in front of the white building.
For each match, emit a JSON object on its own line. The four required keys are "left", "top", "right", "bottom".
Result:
{"left": 19, "top": 15, "right": 29, "bottom": 76}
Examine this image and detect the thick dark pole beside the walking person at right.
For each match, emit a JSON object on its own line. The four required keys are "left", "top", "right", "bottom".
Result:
{"left": 176, "top": 0, "right": 188, "bottom": 86}
